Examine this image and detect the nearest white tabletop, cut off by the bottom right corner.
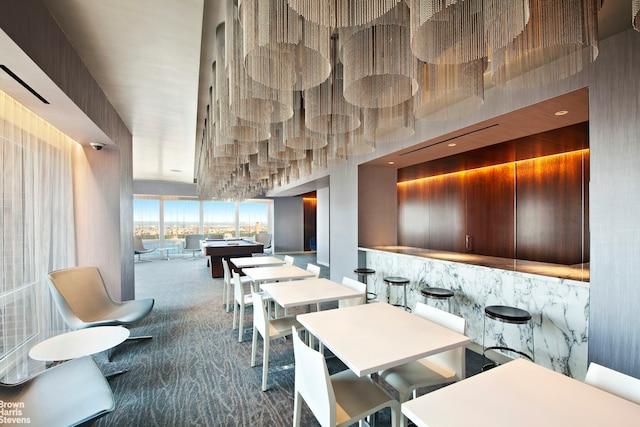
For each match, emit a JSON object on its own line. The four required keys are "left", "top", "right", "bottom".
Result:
{"left": 402, "top": 359, "right": 640, "bottom": 427}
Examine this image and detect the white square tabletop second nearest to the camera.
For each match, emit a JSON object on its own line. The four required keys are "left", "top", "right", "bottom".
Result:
{"left": 297, "top": 302, "right": 470, "bottom": 377}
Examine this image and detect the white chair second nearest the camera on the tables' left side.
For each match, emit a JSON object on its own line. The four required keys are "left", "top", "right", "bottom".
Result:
{"left": 251, "top": 292, "right": 303, "bottom": 391}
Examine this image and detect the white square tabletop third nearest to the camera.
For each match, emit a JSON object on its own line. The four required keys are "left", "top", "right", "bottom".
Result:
{"left": 260, "top": 278, "right": 361, "bottom": 308}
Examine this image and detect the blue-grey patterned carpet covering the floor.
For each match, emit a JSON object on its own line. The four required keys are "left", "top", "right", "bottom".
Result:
{"left": 95, "top": 254, "right": 475, "bottom": 426}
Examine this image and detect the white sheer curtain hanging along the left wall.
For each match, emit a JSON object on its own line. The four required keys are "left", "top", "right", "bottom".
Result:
{"left": 0, "top": 91, "right": 76, "bottom": 382}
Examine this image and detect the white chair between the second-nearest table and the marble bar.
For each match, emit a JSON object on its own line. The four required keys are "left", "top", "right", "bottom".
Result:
{"left": 379, "top": 302, "right": 466, "bottom": 426}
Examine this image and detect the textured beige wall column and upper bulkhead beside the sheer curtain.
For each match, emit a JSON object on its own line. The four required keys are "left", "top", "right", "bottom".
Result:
{"left": 0, "top": 0, "right": 134, "bottom": 299}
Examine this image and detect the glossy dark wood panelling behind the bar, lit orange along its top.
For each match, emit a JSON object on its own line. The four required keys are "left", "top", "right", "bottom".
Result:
{"left": 398, "top": 150, "right": 589, "bottom": 264}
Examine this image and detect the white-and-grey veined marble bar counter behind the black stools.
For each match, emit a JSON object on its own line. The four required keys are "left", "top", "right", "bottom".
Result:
{"left": 358, "top": 246, "right": 589, "bottom": 380}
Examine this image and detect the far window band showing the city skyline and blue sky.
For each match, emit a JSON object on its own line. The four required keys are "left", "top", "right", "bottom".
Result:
{"left": 133, "top": 196, "right": 272, "bottom": 254}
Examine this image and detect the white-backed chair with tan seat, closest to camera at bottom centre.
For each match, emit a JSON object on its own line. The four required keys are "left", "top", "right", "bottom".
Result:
{"left": 292, "top": 327, "right": 400, "bottom": 427}
